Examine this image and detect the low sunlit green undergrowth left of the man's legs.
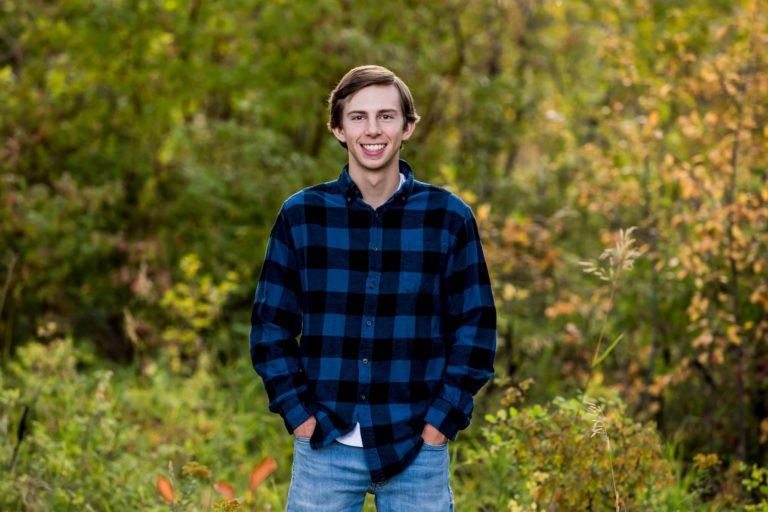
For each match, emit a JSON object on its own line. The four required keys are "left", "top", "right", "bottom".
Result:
{"left": 0, "top": 330, "right": 291, "bottom": 511}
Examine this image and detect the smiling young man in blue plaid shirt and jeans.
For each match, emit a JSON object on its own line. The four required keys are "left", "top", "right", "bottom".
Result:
{"left": 250, "top": 66, "right": 496, "bottom": 511}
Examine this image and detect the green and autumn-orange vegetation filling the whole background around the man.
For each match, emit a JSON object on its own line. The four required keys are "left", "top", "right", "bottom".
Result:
{"left": 0, "top": 0, "right": 768, "bottom": 511}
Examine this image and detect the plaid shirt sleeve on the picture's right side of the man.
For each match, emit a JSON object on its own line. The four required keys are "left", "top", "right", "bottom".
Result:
{"left": 425, "top": 210, "right": 496, "bottom": 440}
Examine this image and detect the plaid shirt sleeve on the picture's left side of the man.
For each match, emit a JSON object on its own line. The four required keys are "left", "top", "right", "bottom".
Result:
{"left": 250, "top": 209, "right": 317, "bottom": 432}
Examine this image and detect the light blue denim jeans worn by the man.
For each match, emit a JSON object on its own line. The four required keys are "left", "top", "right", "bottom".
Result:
{"left": 287, "top": 438, "right": 453, "bottom": 512}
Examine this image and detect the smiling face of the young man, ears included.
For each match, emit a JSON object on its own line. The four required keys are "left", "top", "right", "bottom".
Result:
{"left": 333, "top": 85, "right": 415, "bottom": 172}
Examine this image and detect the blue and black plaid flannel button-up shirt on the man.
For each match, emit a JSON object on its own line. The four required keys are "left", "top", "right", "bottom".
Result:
{"left": 250, "top": 160, "right": 496, "bottom": 482}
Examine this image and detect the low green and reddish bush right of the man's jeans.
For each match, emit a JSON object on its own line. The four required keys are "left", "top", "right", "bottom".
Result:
{"left": 458, "top": 391, "right": 674, "bottom": 510}
